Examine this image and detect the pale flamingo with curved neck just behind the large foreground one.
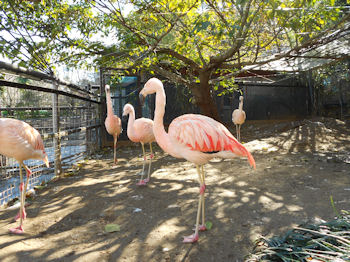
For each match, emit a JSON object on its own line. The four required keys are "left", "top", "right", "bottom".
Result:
{"left": 123, "top": 104, "right": 156, "bottom": 186}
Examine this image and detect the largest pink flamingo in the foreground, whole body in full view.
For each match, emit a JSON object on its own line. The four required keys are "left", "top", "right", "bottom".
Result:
{"left": 140, "top": 78, "right": 255, "bottom": 243}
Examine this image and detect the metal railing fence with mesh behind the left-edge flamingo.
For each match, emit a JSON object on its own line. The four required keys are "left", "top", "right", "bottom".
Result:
{"left": 0, "top": 63, "right": 101, "bottom": 205}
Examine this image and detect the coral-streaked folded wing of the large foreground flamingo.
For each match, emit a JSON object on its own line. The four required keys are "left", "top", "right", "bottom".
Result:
{"left": 169, "top": 114, "right": 239, "bottom": 152}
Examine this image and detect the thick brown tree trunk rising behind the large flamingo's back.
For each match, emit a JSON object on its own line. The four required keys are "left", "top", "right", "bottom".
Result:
{"left": 190, "top": 73, "right": 221, "bottom": 121}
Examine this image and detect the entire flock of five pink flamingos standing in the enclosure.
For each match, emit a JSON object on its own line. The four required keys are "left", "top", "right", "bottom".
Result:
{"left": 0, "top": 78, "right": 255, "bottom": 243}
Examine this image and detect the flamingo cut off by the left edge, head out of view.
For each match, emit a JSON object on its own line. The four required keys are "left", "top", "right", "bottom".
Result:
{"left": 0, "top": 118, "right": 49, "bottom": 234}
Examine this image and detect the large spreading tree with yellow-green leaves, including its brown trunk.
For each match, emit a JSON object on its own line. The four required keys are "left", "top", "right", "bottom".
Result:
{"left": 0, "top": 0, "right": 349, "bottom": 119}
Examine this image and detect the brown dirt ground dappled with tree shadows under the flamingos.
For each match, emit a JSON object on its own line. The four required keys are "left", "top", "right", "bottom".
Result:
{"left": 0, "top": 118, "right": 350, "bottom": 262}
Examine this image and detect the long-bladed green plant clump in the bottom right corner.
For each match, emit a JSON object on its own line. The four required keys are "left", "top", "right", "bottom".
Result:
{"left": 246, "top": 210, "right": 350, "bottom": 262}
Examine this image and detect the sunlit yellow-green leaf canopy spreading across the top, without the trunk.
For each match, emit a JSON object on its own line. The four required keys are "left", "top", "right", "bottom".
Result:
{"left": 0, "top": 0, "right": 341, "bottom": 74}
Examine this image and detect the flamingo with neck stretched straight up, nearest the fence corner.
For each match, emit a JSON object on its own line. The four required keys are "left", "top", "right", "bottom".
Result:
{"left": 105, "top": 85, "right": 122, "bottom": 164}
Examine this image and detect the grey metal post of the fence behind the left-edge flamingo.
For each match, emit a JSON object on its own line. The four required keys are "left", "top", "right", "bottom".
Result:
{"left": 52, "top": 81, "right": 62, "bottom": 177}
